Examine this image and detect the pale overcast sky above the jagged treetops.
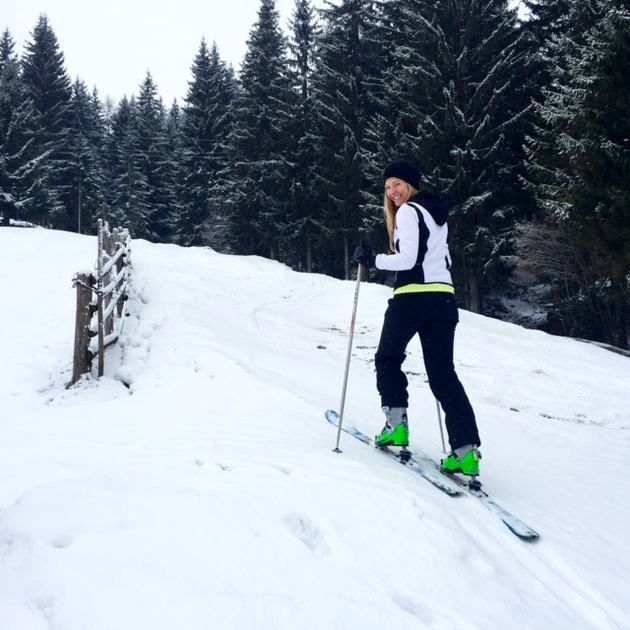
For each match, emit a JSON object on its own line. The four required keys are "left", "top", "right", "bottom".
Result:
{"left": 0, "top": 0, "right": 322, "bottom": 106}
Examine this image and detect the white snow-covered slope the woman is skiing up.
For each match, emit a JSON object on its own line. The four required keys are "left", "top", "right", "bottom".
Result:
{"left": 0, "top": 228, "right": 630, "bottom": 630}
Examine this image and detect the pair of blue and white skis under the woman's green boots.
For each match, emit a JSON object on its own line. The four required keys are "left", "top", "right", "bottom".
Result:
{"left": 326, "top": 409, "right": 539, "bottom": 541}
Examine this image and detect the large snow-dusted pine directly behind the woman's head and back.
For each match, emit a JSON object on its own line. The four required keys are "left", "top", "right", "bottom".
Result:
{"left": 370, "top": 0, "right": 527, "bottom": 312}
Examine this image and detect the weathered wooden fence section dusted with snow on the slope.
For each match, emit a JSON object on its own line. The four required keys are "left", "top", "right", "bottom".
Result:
{"left": 68, "top": 220, "right": 131, "bottom": 386}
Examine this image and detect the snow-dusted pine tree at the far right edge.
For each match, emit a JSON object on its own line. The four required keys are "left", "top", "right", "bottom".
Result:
{"left": 531, "top": 0, "right": 630, "bottom": 348}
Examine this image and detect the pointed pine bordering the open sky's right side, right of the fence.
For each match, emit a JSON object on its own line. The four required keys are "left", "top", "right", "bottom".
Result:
{"left": 177, "top": 40, "right": 234, "bottom": 249}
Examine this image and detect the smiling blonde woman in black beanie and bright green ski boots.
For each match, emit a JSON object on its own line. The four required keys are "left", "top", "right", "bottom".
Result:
{"left": 354, "top": 160, "right": 481, "bottom": 476}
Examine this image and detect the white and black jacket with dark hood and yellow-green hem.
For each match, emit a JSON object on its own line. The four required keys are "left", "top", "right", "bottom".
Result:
{"left": 375, "top": 192, "right": 453, "bottom": 293}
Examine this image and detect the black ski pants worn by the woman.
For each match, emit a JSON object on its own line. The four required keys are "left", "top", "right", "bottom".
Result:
{"left": 375, "top": 293, "right": 481, "bottom": 450}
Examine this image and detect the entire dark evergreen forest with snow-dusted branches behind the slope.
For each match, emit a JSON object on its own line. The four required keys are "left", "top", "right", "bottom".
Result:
{"left": 0, "top": 0, "right": 630, "bottom": 349}
